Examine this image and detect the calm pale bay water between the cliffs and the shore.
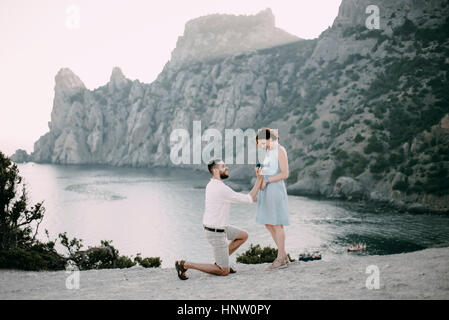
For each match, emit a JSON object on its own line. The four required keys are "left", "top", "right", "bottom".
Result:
{"left": 15, "top": 163, "right": 449, "bottom": 267}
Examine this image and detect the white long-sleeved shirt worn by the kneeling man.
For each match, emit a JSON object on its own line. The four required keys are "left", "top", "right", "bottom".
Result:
{"left": 203, "top": 178, "right": 253, "bottom": 228}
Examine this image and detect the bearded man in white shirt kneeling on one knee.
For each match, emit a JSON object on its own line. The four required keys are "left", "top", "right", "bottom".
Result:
{"left": 175, "top": 159, "right": 263, "bottom": 280}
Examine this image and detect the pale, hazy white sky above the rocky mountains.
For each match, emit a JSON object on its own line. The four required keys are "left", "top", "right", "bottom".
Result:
{"left": 0, "top": 0, "right": 341, "bottom": 156}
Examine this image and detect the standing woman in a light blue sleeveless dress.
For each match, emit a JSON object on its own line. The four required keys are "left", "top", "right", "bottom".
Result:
{"left": 256, "top": 128, "right": 290, "bottom": 270}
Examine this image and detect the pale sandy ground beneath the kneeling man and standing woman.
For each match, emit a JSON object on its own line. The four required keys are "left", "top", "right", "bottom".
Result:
{"left": 0, "top": 248, "right": 449, "bottom": 300}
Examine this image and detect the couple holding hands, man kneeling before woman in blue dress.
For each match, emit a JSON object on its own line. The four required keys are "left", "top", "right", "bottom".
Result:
{"left": 175, "top": 128, "right": 290, "bottom": 280}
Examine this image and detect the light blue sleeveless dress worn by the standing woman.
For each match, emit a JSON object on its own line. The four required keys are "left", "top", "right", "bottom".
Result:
{"left": 256, "top": 148, "right": 290, "bottom": 226}
